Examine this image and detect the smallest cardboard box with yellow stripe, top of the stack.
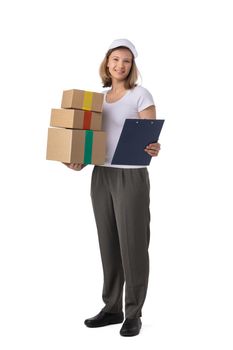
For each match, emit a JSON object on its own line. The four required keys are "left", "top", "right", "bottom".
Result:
{"left": 61, "top": 89, "right": 104, "bottom": 112}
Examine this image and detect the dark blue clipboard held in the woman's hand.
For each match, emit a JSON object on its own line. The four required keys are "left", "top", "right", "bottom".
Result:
{"left": 112, "top": 119, "right": 164, "bottom": 165}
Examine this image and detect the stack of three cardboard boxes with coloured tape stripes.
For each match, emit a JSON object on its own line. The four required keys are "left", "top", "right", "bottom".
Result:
{"left": 46, "top": 90, "right": 106, "bottom": 165}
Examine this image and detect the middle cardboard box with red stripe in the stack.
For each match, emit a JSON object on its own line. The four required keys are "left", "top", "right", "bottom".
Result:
{"left": 50, "top": 109, "right": 102, "bottom": 130}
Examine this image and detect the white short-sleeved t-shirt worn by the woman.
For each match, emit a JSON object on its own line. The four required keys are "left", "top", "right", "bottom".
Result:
{"left": 102, "top": 86, "right": 154, "bottom": 168}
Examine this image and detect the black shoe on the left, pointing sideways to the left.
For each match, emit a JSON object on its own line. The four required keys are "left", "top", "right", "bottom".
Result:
{"left": 84, "top": 311, "right": 124, "bottom": 328}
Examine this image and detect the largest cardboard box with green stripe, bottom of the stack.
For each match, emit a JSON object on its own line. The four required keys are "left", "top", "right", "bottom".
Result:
{"left": 46, "top": 128, "right": 106, "bottom": 165}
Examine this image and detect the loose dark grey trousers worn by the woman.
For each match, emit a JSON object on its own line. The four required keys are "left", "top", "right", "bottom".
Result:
{"left": 91, "top": 166, "right": 150, "bottom": 318}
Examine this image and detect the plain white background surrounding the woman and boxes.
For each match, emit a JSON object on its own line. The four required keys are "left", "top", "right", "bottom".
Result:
{"left": 0, "top": 0, "right": 233, "bottom": 350}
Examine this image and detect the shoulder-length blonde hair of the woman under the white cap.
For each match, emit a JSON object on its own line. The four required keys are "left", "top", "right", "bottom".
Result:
{"left": 99, "top": 46, "right": 139, "bottom": 89}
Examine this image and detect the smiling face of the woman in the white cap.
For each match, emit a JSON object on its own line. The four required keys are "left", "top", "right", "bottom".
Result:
{"left": 107, "top": 49, "right": 133, "bottom": 81}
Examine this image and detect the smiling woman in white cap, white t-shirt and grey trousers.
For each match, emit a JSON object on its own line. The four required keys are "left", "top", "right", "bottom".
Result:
{"left": 65, "top": 39, "right": 160, "bottom": 336}
